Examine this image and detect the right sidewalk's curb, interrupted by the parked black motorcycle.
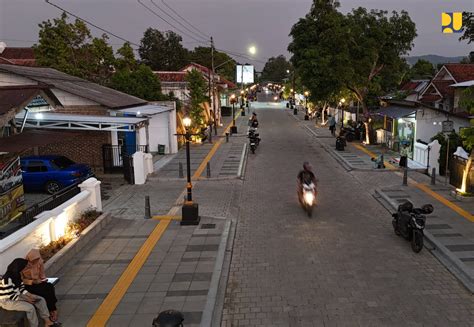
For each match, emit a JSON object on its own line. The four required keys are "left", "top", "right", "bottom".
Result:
{"left": 375, "top": 189, "right": 474, "bottom": 293}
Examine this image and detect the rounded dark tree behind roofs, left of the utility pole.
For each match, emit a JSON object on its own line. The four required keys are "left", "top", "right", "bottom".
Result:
{"left": 138, "top": 27, "right": 189, "bottom": 71}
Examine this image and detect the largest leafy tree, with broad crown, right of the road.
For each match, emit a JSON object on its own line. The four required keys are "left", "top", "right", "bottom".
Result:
{"left": 288, "top": 0, "right": 416, "bottom": 142}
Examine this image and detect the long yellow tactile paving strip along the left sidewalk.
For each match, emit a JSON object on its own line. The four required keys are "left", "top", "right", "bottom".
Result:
{"left": 87, "top": 113, "right": 240, "bottom": 327}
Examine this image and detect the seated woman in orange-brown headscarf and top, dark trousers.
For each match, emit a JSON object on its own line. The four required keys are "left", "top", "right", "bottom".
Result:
{"left": 21, "top": 249, "right": 58, "bottom": 321}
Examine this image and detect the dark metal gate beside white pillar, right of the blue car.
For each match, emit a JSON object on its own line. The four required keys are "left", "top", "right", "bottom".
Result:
{"left": 102, "top": 144, "right": 148, "bottom": 174}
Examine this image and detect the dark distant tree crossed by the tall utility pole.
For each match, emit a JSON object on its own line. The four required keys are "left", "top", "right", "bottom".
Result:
{"left": 190, "top": 47, "right": 236, "bottom": 82}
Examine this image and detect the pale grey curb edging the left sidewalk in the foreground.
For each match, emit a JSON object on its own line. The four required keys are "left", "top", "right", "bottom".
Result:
{"left": 201, "top": 220, "right": 232, "bottom": 327}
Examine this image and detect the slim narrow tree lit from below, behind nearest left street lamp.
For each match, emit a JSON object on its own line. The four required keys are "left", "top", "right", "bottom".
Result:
{"left": 186, "top": 69, "right": 209, "bottom": 130}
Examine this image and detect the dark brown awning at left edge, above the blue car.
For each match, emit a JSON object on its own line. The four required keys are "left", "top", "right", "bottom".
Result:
{"left": 0, "top": 130, "right": 77, "bottom": 153}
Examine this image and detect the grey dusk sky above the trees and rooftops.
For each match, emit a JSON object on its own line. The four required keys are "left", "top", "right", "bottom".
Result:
{"left": 0, "top": 0, "right": 474, "bottom": 69}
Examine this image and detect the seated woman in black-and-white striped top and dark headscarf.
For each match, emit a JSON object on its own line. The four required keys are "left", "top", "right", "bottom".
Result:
{"left": 0, "top": 258, "right": 58, "bottom": 327}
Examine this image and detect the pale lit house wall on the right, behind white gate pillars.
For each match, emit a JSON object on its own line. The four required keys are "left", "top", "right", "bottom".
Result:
{"left": 415, "top": 108, "right": 469, "bottom": 143}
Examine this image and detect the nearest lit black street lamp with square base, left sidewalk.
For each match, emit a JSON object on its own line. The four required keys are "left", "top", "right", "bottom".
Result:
{"left": 181, "top": 117, "right": 201, "bottom": 225}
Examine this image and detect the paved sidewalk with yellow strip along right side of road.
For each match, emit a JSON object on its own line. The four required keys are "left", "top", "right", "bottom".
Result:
{"left": 295, "top": 109, "right": 474, "bottom": 292}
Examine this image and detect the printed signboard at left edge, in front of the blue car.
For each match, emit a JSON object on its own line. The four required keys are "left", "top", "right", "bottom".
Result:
{"left": 0, "top": 158, "right": 25, "bottom": 226}
